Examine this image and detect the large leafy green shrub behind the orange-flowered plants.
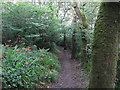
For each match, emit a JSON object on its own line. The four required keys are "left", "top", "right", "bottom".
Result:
{"left": 2, "top": 2, "right": 58, "bottom": 49}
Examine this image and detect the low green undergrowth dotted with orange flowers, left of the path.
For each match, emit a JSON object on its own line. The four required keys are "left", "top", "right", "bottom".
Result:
{"left": 1, "top": 44, "right": 60, "bottom": 88}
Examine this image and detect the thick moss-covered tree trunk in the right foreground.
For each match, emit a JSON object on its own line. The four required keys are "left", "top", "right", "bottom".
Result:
{"left": 89, "top": 2, "right": 119, "bottom": 88}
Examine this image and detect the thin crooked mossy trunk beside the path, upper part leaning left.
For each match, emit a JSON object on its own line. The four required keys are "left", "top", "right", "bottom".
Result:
{"left": 73, "top": 2, "right": 88, "bottom": 62}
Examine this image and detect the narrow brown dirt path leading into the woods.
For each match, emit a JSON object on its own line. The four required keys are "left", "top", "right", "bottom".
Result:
{"left": 51, "top": 48, "right": 86, "bottom": 88}
